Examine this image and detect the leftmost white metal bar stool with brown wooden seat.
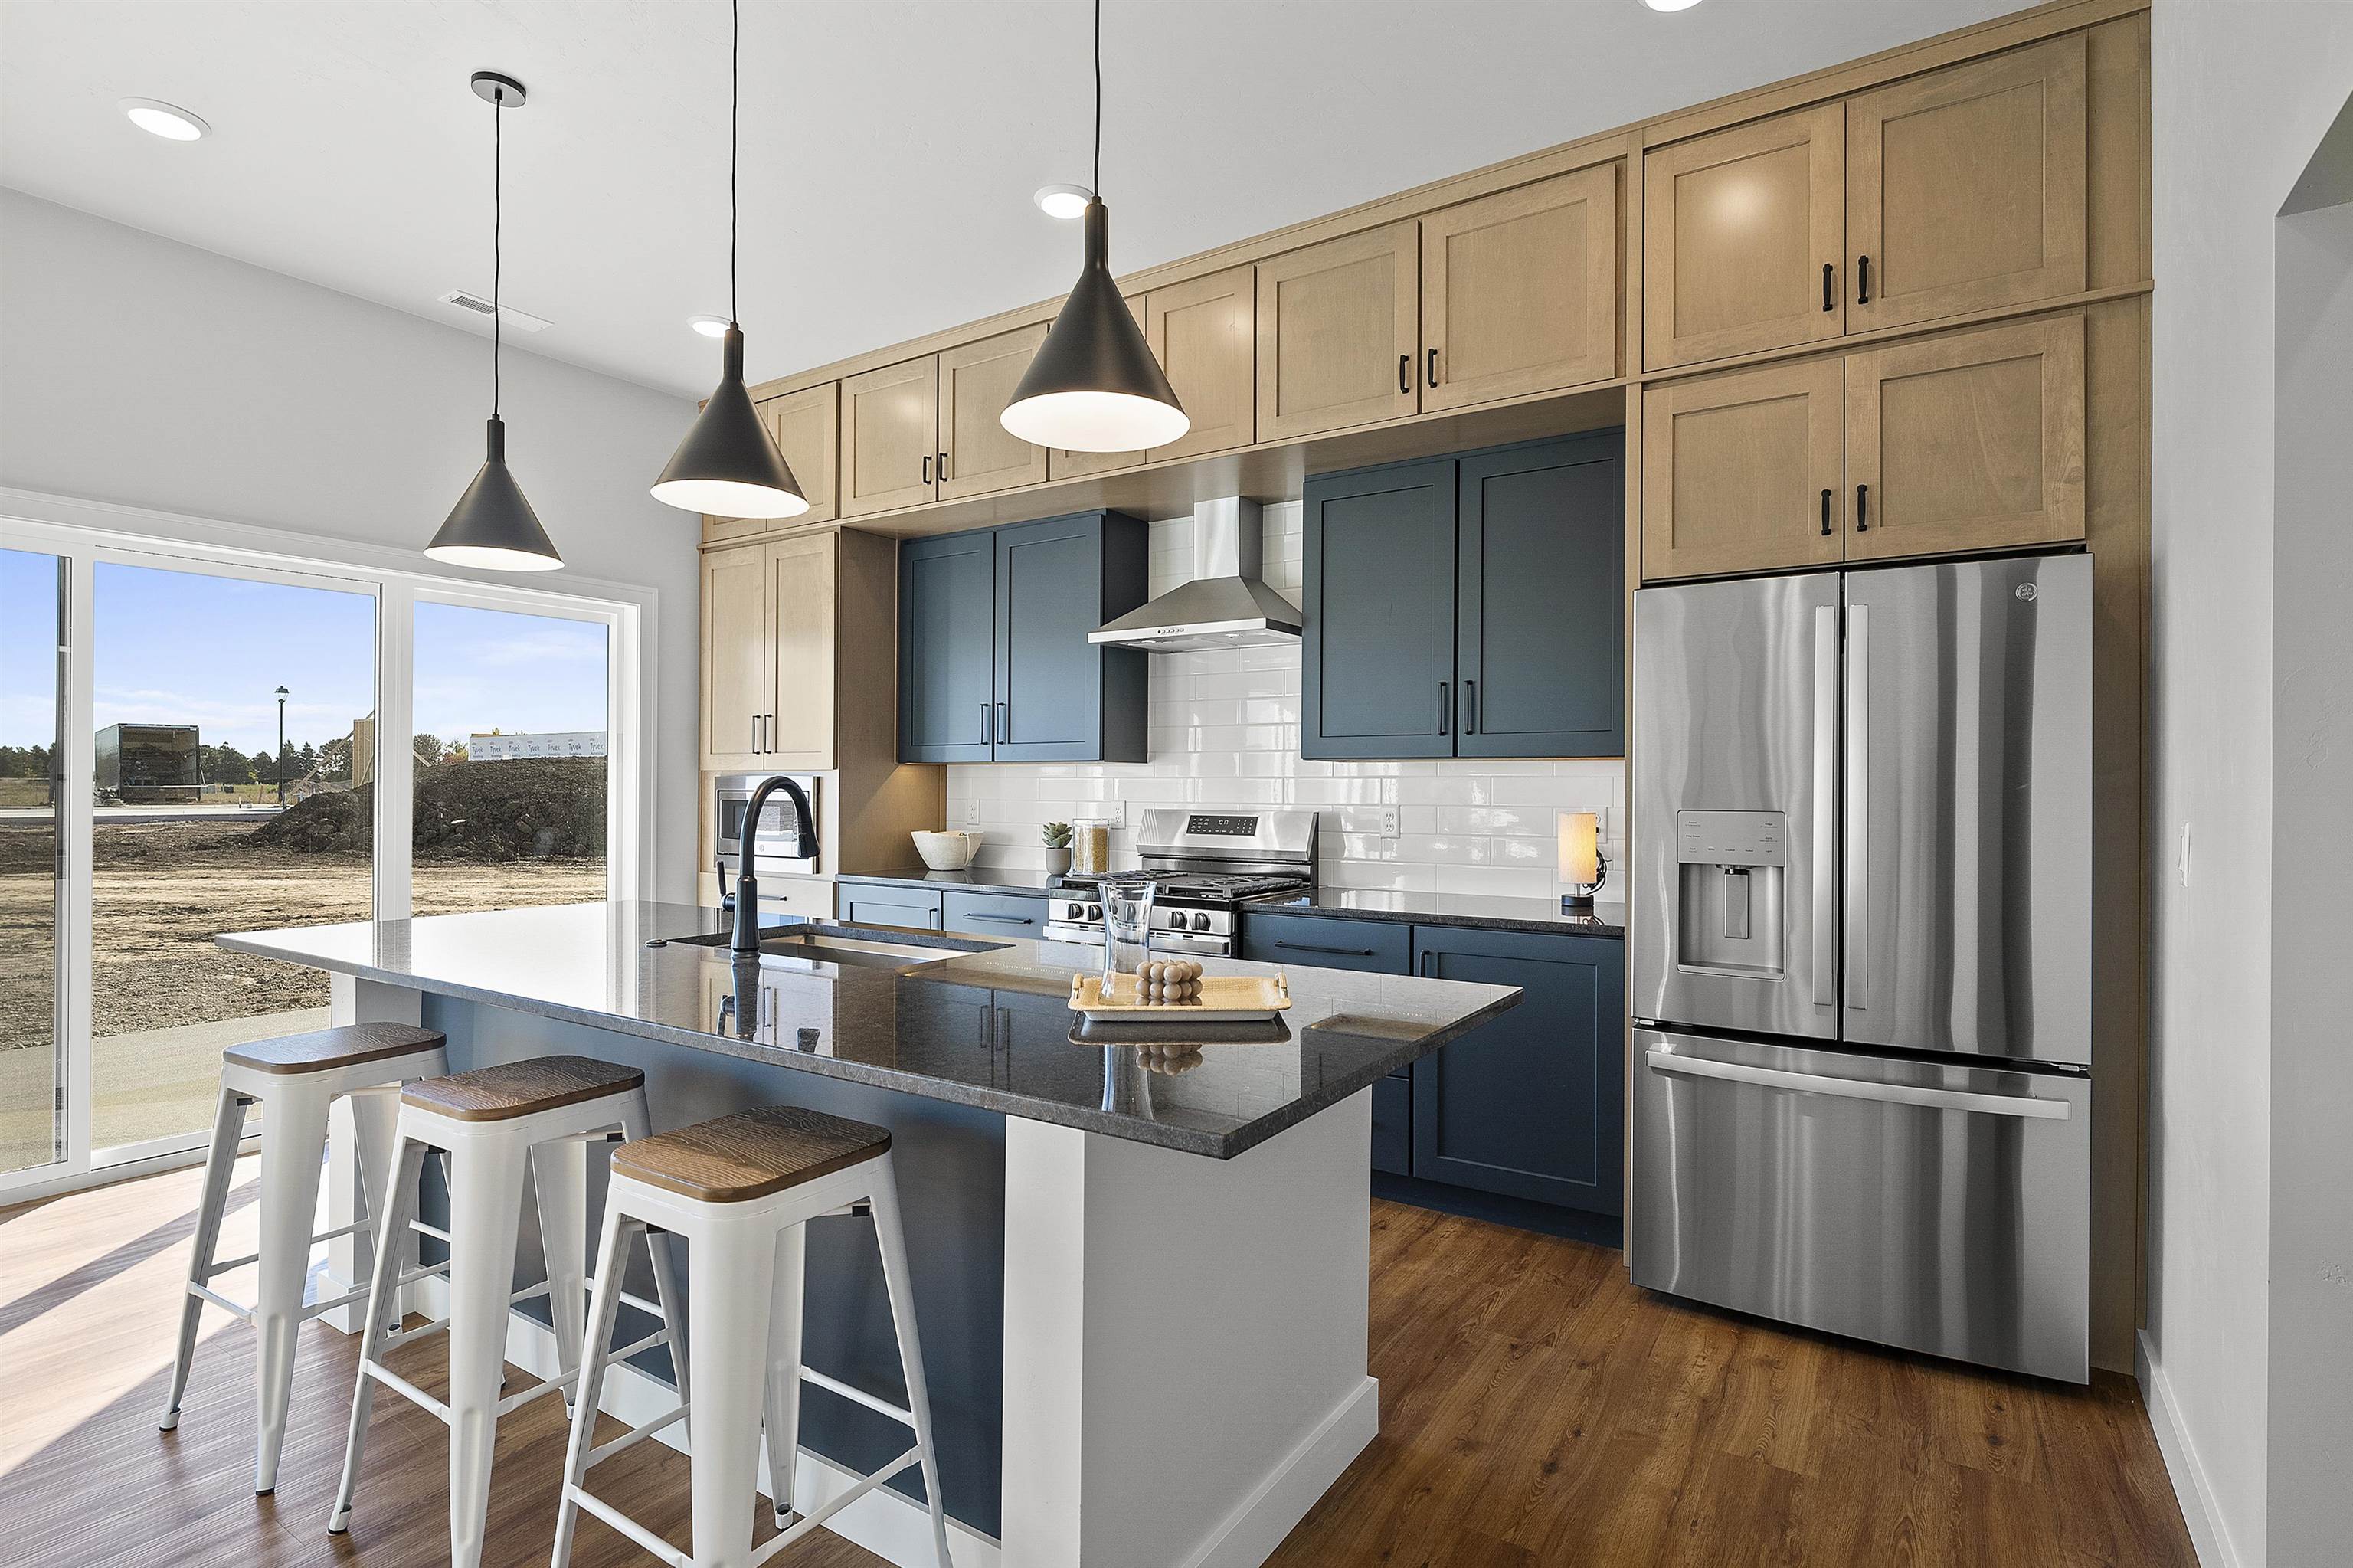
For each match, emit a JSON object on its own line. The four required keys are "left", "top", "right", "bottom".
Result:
{"left": 158, "top": 1024, "right": 450, "bottom": 1493}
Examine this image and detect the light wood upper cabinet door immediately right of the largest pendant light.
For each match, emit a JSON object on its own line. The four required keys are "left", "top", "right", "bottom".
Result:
{"left": 1256, "top": 219, "right": 1421, "bottom": 440}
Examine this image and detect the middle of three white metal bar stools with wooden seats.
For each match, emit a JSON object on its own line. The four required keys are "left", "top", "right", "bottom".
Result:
{"left": 327, "top": 1057, "right": 687, "bottom": 1568}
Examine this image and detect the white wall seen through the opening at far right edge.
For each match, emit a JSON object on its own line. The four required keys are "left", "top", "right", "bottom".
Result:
{"left": 2268, "top": 189, "right": 2353, "bottom": 1563}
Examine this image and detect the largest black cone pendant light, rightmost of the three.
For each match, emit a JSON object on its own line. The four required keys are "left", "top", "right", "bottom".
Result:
{"left": 1000, "top": 0, "right": 1193, "bottom": 452}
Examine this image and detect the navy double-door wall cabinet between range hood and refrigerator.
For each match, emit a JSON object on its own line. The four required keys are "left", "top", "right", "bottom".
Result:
{"left": 1299, "top": 430, "right": 1626, "bottom": 758}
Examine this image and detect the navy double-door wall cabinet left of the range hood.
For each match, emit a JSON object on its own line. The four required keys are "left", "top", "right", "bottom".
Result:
{"left": 899, "top": 511, "right": 1150, "bottom": 763}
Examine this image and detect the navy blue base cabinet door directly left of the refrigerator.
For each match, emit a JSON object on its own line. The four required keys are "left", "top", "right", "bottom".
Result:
{"left": 1412, "top": 925, "right": 1626, "bottom": 1215}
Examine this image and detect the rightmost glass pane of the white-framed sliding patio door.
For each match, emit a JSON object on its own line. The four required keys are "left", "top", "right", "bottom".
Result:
{"left": 410, "top": 603, "right": 607, "bottom": 916}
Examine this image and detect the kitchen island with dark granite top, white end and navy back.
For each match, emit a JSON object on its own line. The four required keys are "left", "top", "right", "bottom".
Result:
{"left": 219, "top": 902, "right": 1517, "bottom": 1568}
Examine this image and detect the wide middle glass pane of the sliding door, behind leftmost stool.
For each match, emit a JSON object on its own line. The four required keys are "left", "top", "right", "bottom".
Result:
{"left": 90, "top": 563, "right": 377, "bottom": 1149}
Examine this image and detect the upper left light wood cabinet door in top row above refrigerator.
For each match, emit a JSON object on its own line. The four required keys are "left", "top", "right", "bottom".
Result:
{"left": 1642, "top": 103, "right": 1847, "bottom": 370}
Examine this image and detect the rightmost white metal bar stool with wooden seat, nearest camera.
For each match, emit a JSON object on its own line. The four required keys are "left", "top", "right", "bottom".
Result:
{"left": 553, "top": 1107, "right": 948, "bottom": 1568}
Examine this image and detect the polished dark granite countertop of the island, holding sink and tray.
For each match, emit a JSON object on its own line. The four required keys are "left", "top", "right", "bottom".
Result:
{"left": 214, "top": 902, "right": 1520, "bottom": 1158}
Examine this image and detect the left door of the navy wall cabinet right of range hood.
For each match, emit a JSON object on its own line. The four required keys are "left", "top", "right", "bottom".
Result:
{"left": 1299, "top": 459, "right": 1454, "bottom": 758}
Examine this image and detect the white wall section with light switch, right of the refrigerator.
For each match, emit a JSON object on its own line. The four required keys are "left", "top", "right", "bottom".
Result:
{"left": 2146, "top": 0, "right": 2353, "bottom": 1568}
